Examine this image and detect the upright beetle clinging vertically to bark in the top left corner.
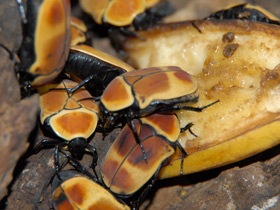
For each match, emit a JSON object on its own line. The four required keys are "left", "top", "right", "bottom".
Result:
{"left": 17, "top": 0, "right": 71, "bottom": 88}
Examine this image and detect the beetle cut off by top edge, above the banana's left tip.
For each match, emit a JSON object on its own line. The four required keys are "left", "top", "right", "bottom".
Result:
{"left": 79, "top": 0, "right": 174, "bottom": 30}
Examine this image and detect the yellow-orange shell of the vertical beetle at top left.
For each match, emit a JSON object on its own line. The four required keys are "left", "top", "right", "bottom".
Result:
{"left": 28, "top": 0, "right": 70, "bottom": 87}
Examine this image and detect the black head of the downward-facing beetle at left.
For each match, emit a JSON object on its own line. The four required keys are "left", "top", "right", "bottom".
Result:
{"left": 68, "top": 138, "right": 87, "bottom": 160}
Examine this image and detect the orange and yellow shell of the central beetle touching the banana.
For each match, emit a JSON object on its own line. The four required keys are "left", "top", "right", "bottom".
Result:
{"left": 101, "top": 66, "right": 197, "bottom": 111}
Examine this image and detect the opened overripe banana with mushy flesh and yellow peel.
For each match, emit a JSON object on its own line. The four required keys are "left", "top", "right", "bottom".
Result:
{"left": 122, "top": 20, "right": 280, "bottom": 179}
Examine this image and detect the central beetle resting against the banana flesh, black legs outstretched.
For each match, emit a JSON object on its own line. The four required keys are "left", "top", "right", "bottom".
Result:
{"left": 99, "top": 66, "right": 218, "bottom": 159}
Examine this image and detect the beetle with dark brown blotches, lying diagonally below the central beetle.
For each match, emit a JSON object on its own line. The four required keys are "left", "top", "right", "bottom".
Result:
{"left": 101, "top": 113, "right": 195, "bottom": 203}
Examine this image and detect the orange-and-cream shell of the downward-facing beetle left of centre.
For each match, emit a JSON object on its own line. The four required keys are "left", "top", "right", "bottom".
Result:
{"left": 39, "top": 80, "right": 99, "bottom": 140}
